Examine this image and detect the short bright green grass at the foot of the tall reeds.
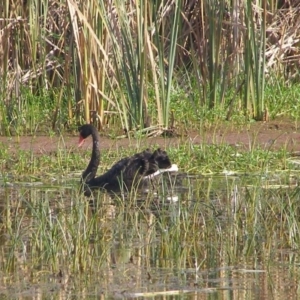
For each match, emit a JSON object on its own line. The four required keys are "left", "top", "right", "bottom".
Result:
{"left": 0, "top": 80, "right": 300, "bottom": 137}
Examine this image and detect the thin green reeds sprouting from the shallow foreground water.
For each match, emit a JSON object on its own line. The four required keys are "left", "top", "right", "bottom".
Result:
{"left": 0, "top": 172, "right": 299, "bottom": 294}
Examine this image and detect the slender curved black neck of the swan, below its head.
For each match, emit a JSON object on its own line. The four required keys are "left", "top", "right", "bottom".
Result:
{"left": 82, "top": 130, "right": 100, "bottom": 182}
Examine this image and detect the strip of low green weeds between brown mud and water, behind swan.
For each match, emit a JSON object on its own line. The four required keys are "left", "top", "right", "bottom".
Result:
{"left": 0, "top": 136, "right": 292, "bottom": 183}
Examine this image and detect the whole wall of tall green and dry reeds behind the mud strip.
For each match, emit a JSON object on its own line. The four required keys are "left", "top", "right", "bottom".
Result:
{"left": 0, "top": 0, "right": 300, "bottom": 134}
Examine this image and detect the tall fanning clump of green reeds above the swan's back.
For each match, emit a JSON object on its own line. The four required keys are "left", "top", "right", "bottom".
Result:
{"left": 95, "top": 1, "right": 181, "bottom": 129}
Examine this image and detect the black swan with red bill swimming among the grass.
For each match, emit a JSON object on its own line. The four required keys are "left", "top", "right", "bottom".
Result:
{"left": 78, "top": 124, "right": 178, "bottom": 196}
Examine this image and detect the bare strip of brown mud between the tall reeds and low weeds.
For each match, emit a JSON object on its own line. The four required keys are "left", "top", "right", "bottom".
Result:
{"left": 0, "top": 120, "right": 300, "bottom": 154}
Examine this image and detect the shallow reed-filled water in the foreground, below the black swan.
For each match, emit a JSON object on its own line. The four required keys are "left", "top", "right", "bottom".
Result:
{"left": 0, "top": 174, "right": 300, "bottom": 299}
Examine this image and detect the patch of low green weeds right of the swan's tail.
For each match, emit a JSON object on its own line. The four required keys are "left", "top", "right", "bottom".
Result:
{"left": 169, "top": 144, "right": 291, "bottom": 175}
